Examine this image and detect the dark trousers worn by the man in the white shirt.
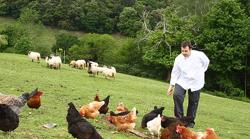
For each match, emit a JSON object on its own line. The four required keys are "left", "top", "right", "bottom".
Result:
{"left": 174, "top": 84, "right": 200, "bottom": 123}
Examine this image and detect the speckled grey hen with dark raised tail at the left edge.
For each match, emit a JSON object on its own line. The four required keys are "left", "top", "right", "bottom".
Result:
{"left": 0, "top": 88, "right": 37, "bottom": 115}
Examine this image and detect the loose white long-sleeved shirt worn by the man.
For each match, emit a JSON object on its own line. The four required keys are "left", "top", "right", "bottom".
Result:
{"left": 170, "top": 50, "right": 209, "bottom": 92}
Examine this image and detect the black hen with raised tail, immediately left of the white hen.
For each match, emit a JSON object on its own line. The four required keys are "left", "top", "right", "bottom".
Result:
{"left": 141, "top": 106, "right": 164, "bottom": 128}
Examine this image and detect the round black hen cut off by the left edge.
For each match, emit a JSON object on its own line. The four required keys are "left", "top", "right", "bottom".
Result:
{"left": 0, "top": 104, "right": 19, "bottom": 132}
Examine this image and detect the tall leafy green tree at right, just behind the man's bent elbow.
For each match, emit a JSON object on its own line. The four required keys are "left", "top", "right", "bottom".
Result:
{"left": 197, "top": 0, "right": 248, "bottom": 96}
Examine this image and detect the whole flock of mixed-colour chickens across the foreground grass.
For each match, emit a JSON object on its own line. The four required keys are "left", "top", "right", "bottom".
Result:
{"left": 0, "top": 88, "right": 217, "bottom": 139}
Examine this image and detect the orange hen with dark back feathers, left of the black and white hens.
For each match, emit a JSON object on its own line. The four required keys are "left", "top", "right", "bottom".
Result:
{"left": 107, "top": 107, "right": 137, "bottom": 131}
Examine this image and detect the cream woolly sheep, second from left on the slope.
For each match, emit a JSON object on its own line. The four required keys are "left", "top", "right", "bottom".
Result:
{"left": 45, "top": 56, "right": 62, "bottom": 69}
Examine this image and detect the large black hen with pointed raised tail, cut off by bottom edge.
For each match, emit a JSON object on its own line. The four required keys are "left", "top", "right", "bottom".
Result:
{"left": 66, "top": 102, "right": 102, "bottom": 139}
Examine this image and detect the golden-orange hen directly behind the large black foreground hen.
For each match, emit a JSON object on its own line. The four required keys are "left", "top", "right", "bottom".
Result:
{"left": 80, "top": 101, "right": 105, "bottom": 119}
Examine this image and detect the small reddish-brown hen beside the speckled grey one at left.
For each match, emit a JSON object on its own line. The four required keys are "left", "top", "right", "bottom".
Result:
{"left": 27, "top": 88, "right": 43, "bottom": 109}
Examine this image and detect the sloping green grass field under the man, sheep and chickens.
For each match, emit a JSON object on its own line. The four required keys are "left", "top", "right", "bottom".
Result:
{"left": 0, "top": 53, "right": 250, "bottom": 139}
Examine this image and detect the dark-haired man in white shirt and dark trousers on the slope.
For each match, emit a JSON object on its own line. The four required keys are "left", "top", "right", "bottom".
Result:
{"left": 167, "top": 41, "right": 209, "bottom": 128}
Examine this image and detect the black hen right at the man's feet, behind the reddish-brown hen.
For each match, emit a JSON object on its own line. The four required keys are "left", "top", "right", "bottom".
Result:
{"left": 161, "top": 115, "right": 192, "bottom": 128}
